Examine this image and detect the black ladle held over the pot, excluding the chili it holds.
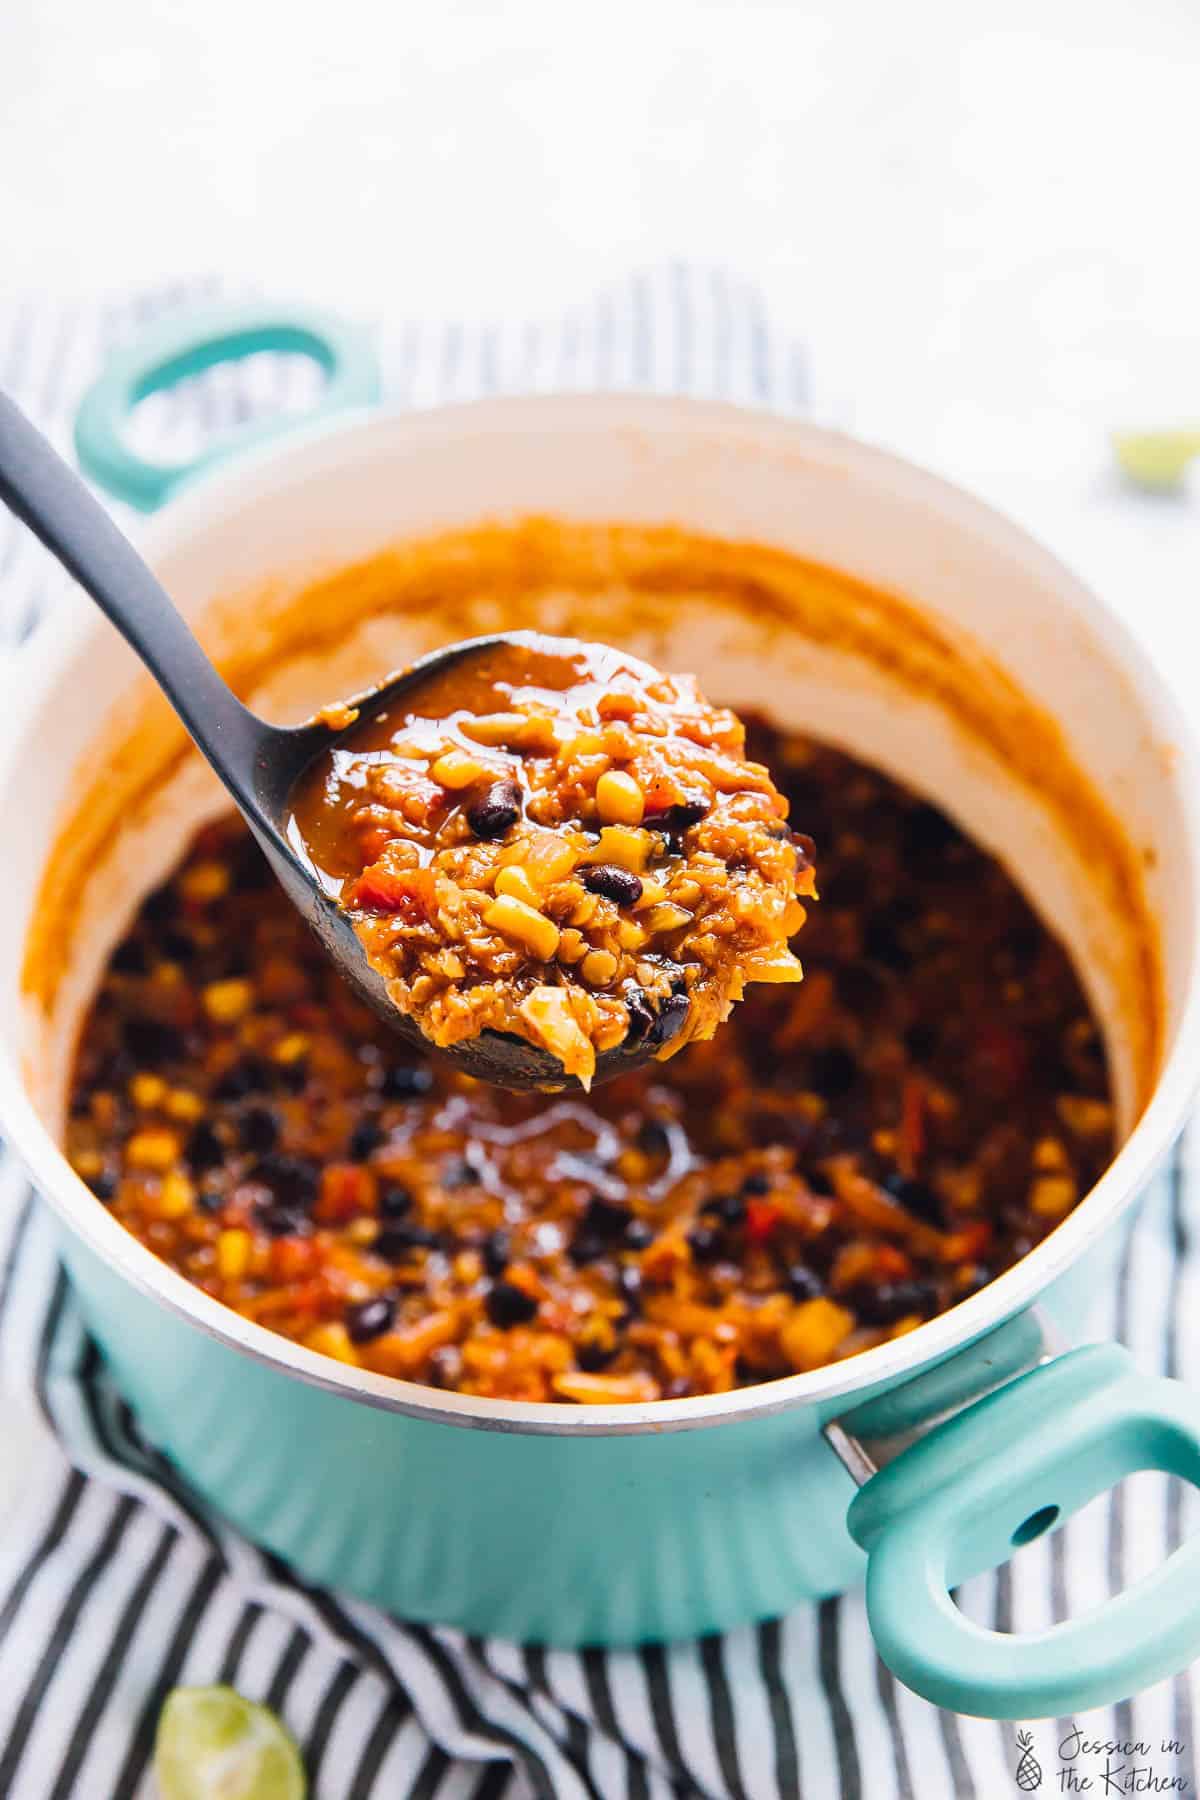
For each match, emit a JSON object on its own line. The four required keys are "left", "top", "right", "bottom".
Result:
{"left": 0, "top": 394, "right": 676, "bottom": 1087}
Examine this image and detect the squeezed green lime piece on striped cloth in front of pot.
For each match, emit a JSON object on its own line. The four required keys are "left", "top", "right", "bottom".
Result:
{"left": 155, "top": 1687, "right": 308, "bottom": 1800}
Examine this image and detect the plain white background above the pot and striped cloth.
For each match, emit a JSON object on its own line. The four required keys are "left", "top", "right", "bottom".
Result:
{"left": 0, "top": 0, "right": 1200, "bottom": 1504}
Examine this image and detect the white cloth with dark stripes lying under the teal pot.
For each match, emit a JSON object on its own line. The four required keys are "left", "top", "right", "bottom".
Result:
{"left": 0, "top": 266, "right": 1200, "bottom": 1800}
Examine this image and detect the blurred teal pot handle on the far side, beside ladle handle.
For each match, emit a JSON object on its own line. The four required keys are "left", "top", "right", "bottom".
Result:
{"left": 76, "top": 302, "right": 380, "bottom": 513}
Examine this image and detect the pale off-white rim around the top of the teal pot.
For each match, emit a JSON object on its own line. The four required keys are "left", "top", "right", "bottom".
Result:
{"left": 0, "top": 392, "right": 1200, "bottom": 1436}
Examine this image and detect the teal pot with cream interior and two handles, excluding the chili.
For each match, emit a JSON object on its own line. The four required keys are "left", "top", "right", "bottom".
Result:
{"left": 0, "top": 310, "right": 1200, "bottom": 1717}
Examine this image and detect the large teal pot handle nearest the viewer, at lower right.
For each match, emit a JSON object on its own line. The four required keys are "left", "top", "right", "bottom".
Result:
{"left": 831, "top": 1345, "right": 1200, "bottom": 1719}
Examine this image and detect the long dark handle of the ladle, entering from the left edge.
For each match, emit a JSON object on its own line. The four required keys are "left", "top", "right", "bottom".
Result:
{"left": 0, "top": 394, "right": 270, "bottom": 815}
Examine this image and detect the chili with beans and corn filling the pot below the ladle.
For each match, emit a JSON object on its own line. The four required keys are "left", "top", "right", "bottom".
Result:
{"left": 68, "top": 722, "right": 1112, "bottom": 1402}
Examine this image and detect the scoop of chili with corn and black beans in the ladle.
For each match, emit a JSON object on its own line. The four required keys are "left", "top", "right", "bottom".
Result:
{"left": 291, "top": 632, "right": 813, "bottom": 1087}
